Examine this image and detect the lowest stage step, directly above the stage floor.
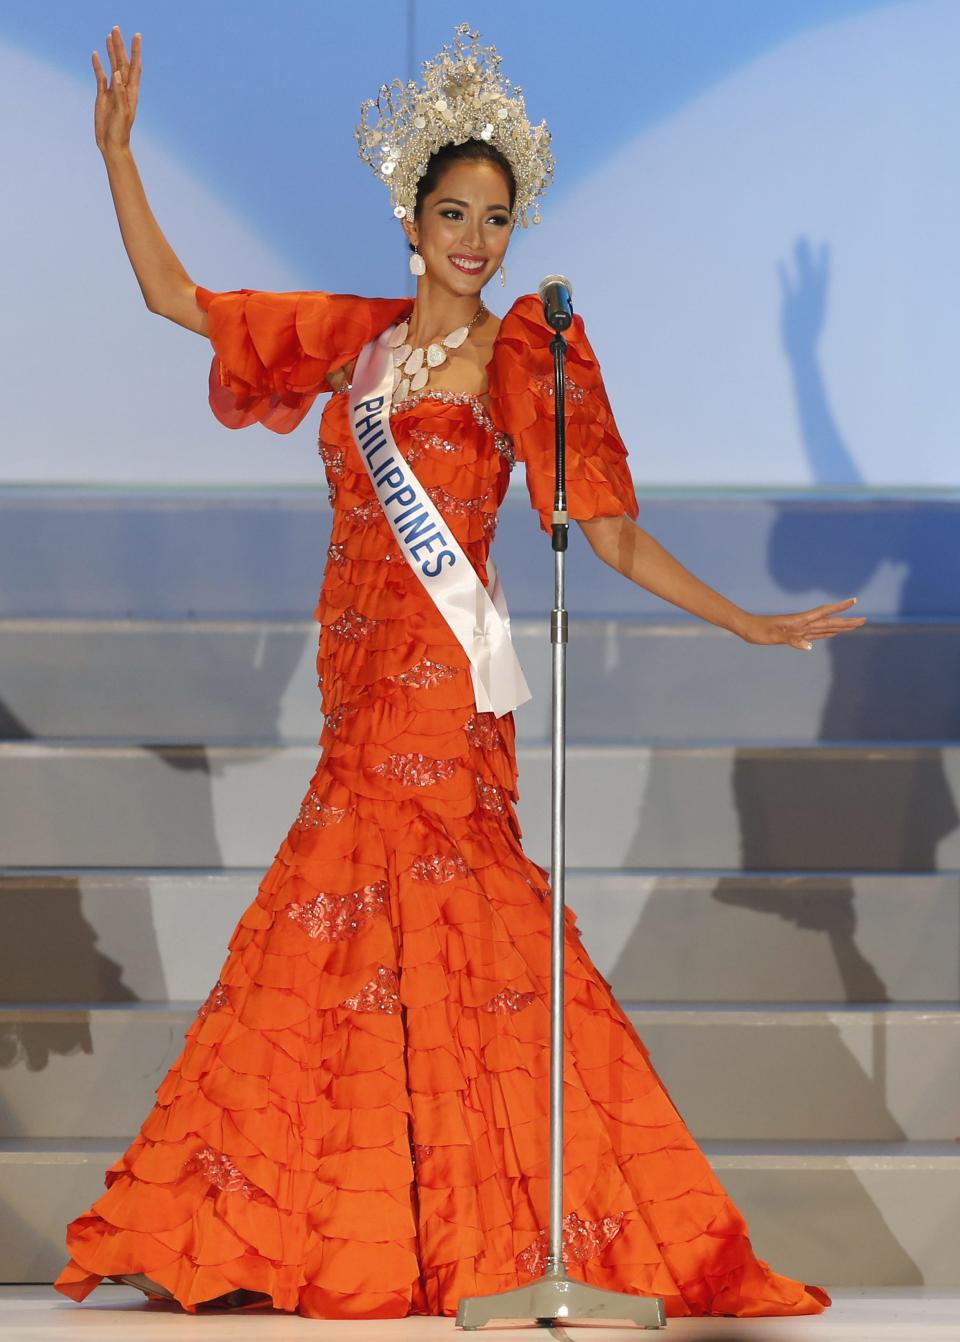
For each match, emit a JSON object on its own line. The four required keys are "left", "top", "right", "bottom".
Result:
{"left": 0, "top": 1139, "right": 960, "bottom": 1288}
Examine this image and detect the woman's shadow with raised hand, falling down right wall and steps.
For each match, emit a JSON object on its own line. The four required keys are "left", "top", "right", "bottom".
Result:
{"left": 714, "top": 238, "right": 945, "bottom": 1284}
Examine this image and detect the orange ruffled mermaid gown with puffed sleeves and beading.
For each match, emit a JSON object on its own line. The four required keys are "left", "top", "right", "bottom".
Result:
{"left": 56, "top": 289, "right": 830, "bottom": 1318}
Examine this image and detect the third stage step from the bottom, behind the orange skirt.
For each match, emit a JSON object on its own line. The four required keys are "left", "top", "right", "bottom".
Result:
{"left": 0, "top": 868, "right": 960, "bottom": 1005}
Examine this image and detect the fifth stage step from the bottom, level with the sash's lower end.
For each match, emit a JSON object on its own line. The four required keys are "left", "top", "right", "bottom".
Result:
{"left": 0, "top": 616, "right": 960, "bottom": 745}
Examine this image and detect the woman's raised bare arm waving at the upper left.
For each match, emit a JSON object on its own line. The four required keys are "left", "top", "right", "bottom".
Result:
{"left": 93, "top": 28, "right": 207, "bottom": 336}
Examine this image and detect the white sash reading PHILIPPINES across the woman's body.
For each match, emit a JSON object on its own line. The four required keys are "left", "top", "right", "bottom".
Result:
{"left": 350, "top": 326, "right": 530, "bottom": 718}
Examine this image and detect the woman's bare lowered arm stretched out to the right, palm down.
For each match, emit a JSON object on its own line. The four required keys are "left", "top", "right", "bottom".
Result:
{"left": 580, "top": 515, "right": 866, "bottom": 651}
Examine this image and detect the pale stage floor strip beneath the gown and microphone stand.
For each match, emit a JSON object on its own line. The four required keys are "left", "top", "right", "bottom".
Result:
{"left": 0, "top": 1286, "right": 960, "bottom": 1342}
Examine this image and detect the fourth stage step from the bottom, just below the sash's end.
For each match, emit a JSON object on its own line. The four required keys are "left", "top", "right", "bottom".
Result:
{"left": 0, "top": 741, "right": 960, "bottom": 871}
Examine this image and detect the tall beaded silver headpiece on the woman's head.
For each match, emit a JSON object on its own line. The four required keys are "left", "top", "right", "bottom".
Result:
{"left": 354, "top": 23, "right": 553, "bottom": 227}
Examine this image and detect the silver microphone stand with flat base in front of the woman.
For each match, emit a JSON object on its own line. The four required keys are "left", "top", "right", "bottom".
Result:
{"left": 457, "top": 313, "right": 666, "bottom": 1329}
